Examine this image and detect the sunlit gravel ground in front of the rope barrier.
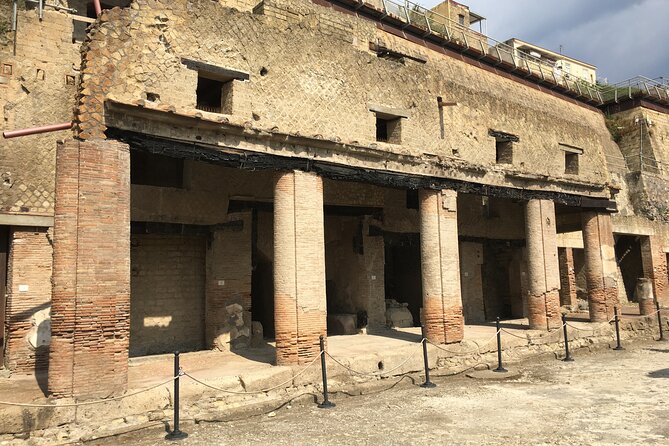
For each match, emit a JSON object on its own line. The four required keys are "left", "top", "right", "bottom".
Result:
{"left": 87, "top": 342, "right": 669, "bottom": 446}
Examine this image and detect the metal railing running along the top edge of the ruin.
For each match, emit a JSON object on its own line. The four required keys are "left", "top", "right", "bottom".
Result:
{"left": 374, "top": 0, "right": 604, "bottom": 103}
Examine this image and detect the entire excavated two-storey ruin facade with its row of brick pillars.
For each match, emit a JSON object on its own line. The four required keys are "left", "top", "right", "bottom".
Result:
{"left": 0, "top": 0, "right": 669, "bottom": 397}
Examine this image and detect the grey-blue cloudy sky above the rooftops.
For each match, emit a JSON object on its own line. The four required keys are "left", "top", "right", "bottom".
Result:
{"left": 420, "top": 0, "right": 669, "bottom": 82}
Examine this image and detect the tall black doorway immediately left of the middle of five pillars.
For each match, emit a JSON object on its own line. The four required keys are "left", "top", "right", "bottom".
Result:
{"left": 383, "top": 232, "right": 423, "bottom": 327}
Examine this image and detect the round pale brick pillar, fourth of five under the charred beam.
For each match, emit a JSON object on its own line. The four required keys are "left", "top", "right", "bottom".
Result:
{"left": 525, "top": 200, "right": 560, "bottom": 330}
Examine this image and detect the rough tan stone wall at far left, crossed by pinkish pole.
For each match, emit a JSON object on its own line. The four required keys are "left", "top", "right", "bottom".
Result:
{"left": 0, "top": 5, "right": 81, "bottom": 216}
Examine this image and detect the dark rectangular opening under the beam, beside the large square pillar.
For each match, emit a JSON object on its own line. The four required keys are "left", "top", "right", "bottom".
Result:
{"left": 130, "top": 150, "right": 184, "bottom": 188}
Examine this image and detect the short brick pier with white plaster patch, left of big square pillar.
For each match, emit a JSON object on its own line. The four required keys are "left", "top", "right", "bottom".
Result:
{"left": 5, "top": 227, "right": 53, "bottom": 373}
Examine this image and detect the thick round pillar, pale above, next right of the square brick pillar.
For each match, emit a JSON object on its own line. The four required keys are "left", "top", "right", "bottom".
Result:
{"left": 274, "top": 171, "right": 327, "bottom": 365}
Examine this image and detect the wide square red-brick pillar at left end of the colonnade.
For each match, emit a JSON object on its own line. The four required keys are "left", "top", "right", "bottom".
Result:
{"left": 48, "top": 140, "right": 130, "bottom": 398}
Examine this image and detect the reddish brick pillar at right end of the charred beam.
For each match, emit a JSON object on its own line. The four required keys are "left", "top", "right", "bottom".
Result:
{"left": 581, "top": 211, "right": 618, "bottom": 322}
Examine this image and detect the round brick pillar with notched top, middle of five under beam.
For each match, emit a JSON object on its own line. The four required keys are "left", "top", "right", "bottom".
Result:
{"left": 419, "top": 190, "right": 464, "bottom": 344}
